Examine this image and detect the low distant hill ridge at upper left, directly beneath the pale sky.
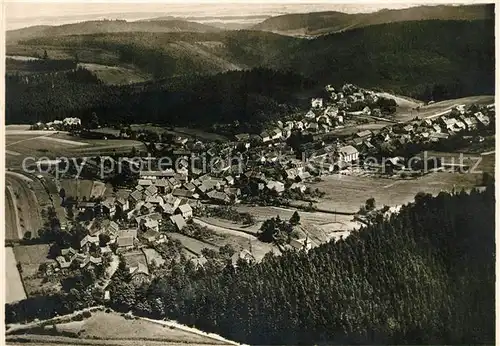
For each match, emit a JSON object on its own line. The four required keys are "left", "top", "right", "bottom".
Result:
{"left": 6, "top": 17, "right": 220, "bottom": 44}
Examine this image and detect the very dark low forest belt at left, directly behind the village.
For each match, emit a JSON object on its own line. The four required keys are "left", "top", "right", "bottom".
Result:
{"left": 6, "top": 69, "right": 316, "bottom": 133}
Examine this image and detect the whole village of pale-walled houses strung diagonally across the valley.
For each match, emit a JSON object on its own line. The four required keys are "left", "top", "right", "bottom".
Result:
{"left": 45, "top": 84, "right": 494, "bottom": 274}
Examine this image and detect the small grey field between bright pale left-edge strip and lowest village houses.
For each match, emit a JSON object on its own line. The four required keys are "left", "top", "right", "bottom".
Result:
{"left": 13, "top": 244, "right": 60, "bottom": 297}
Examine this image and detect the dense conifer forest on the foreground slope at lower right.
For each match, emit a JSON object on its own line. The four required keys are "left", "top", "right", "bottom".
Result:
{"left": 112, "top": 187, "right": 495, "bottom": 345}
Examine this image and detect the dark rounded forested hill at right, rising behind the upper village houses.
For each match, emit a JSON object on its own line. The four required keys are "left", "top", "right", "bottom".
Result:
{"left": 288, "top": 20, "right": 495, "bottom": 101}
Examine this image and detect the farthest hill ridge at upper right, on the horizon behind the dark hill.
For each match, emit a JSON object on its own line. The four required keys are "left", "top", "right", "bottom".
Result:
{"left": 252, "top": 4, "right": 495, "bottom": 36}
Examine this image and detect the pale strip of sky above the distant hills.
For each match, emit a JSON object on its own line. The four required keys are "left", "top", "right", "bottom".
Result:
{"left": 4, "top": 0, "right": 428, "bottom": 30}
